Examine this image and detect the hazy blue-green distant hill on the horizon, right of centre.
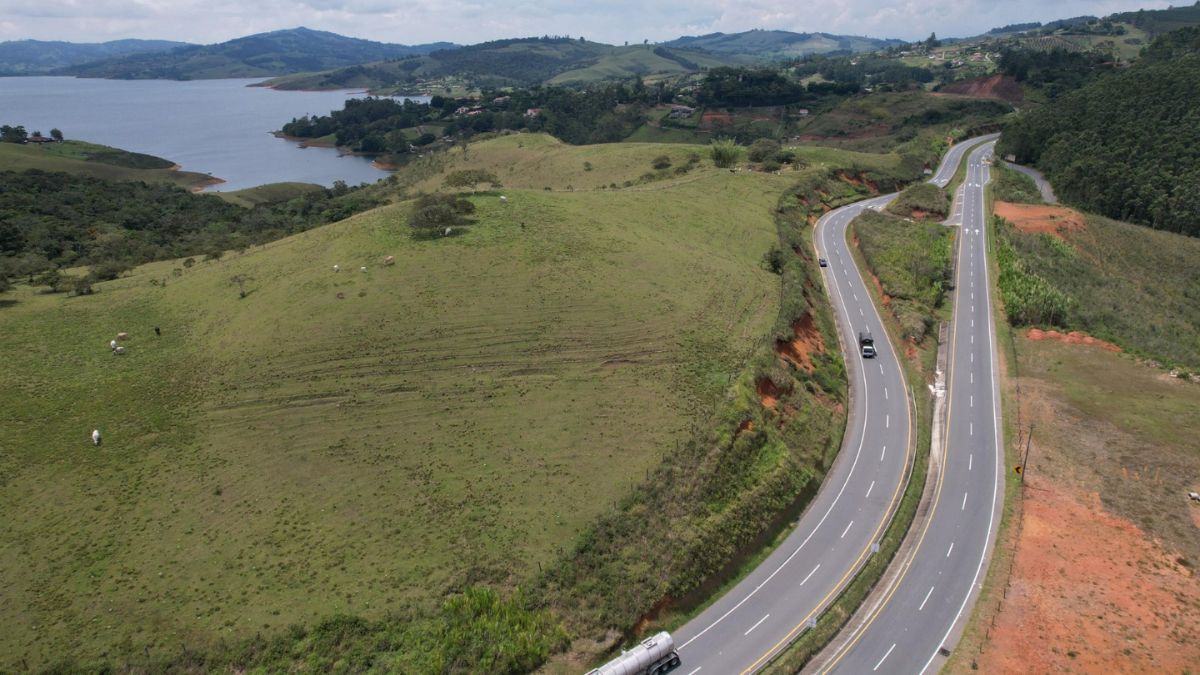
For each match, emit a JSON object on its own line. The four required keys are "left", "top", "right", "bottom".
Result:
{"left": 662, "top": 30, "right": 905, "bottom": 60}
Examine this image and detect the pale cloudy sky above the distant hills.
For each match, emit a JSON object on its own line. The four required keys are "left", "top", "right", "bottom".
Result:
{"left": 0, "top": 0, "right": 1184, "bottom": 44}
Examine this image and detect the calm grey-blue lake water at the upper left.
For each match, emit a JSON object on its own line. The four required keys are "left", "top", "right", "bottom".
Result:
{"left": 0, "top": 77, "right": 424, "bottom": 190}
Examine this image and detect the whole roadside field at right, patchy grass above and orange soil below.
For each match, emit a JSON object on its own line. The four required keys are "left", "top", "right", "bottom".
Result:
{"left": 948, "top": 336, "right": 1200, "bottom": 674}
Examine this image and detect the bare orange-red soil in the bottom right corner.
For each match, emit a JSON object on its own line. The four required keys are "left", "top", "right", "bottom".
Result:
{"left": 973, "top": 477, "right": 1200, "bottom": 674}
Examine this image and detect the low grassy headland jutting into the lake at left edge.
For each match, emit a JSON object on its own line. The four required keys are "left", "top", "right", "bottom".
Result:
{"left": 0, "top": 141, "right": 212, "bottom": 187}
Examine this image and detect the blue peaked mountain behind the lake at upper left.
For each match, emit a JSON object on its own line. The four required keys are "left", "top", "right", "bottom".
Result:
{"left": 51, "top": 28, "right": 455, "bottom": 79}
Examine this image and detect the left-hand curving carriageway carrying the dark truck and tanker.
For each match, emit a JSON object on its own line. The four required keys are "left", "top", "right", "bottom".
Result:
{"left": 674, "top": 132, "right": 994, "bottom": 675}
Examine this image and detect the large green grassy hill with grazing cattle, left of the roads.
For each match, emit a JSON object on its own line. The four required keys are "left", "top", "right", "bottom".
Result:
{"left": 0, "top": 140, "right": 786, "bottom": 670}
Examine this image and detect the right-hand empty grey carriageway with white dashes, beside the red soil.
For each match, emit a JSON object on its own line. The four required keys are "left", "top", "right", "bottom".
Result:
{"left": 822, "top": 143, "right": 1003, "bottom": 674}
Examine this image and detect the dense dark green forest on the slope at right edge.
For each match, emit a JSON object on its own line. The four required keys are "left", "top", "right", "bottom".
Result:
{"left": 1000, "top": 28, "right": 1200, "bottom": 235}
